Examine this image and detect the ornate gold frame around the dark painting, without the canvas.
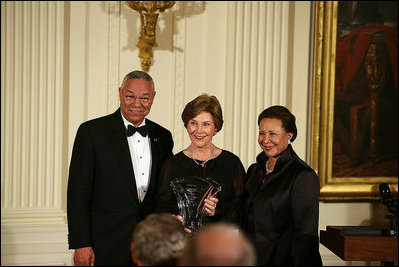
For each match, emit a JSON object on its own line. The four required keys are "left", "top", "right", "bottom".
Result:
{"left": 310, "top": 1, "right": 398, "bottom": 201}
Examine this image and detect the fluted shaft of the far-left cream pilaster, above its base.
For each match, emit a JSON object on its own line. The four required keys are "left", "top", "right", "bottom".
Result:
{"left": 1, "top": 1, "right": 64, "bottom": 217}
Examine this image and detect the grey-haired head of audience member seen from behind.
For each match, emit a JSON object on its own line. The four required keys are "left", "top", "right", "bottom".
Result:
{"left": 131, "top": 213, "right": 187, "bottom": 266}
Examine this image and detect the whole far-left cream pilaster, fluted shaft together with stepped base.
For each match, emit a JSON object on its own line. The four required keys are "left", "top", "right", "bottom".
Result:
{"left": 1, "top": 1, "right": 72, "bottom": 265}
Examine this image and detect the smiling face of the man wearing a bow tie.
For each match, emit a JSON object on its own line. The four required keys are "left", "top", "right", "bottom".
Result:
{"left": 119, "top": 79, "right": 155, "bottom": 127}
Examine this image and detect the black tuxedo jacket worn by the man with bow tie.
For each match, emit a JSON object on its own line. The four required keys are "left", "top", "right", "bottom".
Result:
{"left": 67, "top": 109, "right": 173, "bottom": 266}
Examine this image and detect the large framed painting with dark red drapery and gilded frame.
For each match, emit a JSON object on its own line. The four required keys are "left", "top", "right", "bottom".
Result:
{"left": 310, "top": 1, "right": 398, "bottom": 201}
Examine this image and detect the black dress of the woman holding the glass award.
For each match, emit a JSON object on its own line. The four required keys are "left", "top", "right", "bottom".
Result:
{"left": 156, "top": 150, "right": 245, "bottom": 224}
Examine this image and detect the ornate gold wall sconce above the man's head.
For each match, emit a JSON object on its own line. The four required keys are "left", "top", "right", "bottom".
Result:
{"left": 125, "top": 1, "right": 175, "bottom": 72}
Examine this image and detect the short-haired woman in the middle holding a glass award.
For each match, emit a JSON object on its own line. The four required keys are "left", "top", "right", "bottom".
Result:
{"left": 157, "top": 94, "right": 246, "bottom": 231}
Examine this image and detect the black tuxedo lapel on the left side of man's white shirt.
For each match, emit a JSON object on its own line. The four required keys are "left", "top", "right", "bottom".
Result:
{"left": 107, "top": 109, "right": 138, "bottom": 201}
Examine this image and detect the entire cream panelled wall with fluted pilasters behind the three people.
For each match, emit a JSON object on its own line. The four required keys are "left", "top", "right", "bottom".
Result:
{"left": 1, "top": 1, "right": 388, "bottom": 265}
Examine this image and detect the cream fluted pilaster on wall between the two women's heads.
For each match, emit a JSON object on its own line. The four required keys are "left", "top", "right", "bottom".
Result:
{"left": 224, "top": 1, "right": 289, "bottom": 166}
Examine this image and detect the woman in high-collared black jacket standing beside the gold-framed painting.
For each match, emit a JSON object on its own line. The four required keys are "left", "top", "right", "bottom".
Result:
{"left": 243, "top": 106, "right": 322, "bottom": 266}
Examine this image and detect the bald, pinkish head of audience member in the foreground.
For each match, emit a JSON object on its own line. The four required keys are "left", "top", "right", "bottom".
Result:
{"left": 182, "top": 222, "right": 256, "bottom": 266}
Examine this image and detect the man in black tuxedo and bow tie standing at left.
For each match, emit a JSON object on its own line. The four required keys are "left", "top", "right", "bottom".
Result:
{"left": 67, "top": 71, "right": 173, "bottom": 266}
